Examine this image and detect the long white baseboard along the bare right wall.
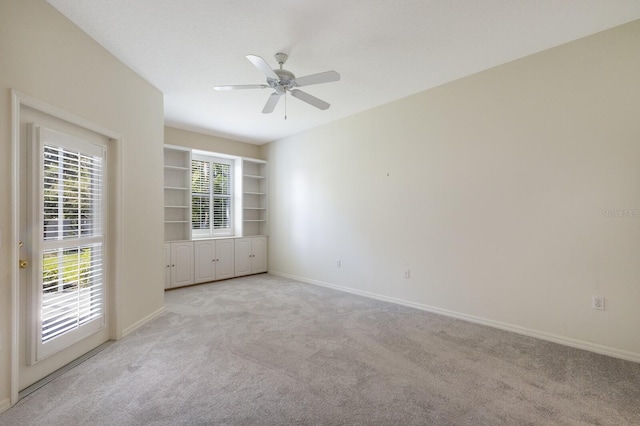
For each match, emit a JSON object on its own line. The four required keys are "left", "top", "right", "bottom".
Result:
{"left": 269, "top": 271, "right": 640, "bottom": 363}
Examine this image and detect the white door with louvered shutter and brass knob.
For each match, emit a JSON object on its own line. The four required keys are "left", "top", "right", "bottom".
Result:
{"left": 18, "top": 118, "right": 109, "bottom": 390}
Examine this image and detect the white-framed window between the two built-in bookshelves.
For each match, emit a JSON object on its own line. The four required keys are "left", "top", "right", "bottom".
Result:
{"left": 191, "top": 154, "right": 233, "bottom": 237}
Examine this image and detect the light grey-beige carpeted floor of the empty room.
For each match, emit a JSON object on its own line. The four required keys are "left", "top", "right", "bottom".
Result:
{"left": 0, "top": 274, "right": 640, "bottom": 426}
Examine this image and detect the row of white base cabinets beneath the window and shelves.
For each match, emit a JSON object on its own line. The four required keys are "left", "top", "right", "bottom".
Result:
{"left": 164, "top": 236, "right": 267, "bottom": 289}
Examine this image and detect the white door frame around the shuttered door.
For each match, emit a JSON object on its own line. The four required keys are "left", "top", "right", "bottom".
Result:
{"left": 9, "top": 89, "right": 124, "bottom": 405}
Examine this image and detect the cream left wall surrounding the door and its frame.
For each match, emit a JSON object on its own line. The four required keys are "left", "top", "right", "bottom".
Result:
{"left": 0, "top": 0, "right": 164, "bottom": 411}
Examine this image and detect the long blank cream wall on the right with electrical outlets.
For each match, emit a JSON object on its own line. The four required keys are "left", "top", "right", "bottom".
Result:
{"left": 263, "top": 21, "right": 640, "bottom": 361}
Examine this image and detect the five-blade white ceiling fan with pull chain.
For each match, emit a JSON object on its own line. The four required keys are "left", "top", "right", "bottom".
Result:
{"left": 214, "top": 53, "right": 340, "bottom": 117}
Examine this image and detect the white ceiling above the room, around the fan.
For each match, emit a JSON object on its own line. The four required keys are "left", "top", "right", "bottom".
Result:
{"left": 48, "top": 0, "right": 640, "bottom": 144}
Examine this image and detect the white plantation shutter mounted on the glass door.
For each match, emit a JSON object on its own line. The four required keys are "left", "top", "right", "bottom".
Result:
{"left": 36, "top": 125, "right": 105, "bottom": 359}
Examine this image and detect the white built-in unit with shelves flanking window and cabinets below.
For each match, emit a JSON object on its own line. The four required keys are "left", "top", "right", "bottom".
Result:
{"left": 164, "top": 145, "right": 267, "bottom": 288}
